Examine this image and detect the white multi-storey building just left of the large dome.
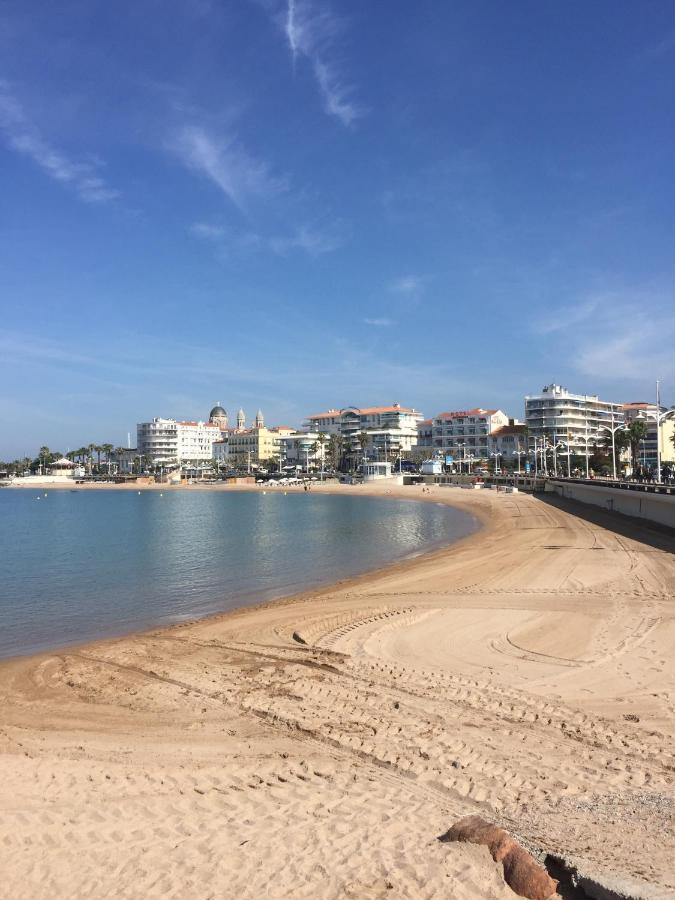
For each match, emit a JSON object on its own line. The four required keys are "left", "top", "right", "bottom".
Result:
{"left": 136, "top": 417, "right": 221, "bottom": 466}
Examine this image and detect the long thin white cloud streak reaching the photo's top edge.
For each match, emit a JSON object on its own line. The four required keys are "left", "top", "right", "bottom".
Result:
{"left": 276, "top": 0, "right": 365, "bottom": 126}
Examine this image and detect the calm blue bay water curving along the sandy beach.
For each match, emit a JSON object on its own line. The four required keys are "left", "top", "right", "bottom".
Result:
{"left": 0, "top": 489, "right": 478, "bottom": 657}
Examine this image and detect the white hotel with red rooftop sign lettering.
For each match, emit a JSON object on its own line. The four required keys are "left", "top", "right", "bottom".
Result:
{"left": 431, "top": 406, "right": 509, "bottom": 462}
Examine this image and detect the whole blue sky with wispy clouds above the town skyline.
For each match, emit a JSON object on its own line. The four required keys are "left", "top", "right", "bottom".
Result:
{"left": 0, "top": 0, "right": 675, "bottom": 459}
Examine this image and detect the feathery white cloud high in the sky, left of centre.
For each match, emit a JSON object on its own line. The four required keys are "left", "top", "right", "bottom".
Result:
{"left": 168, "top": 126, "right": 288, "bottom": 211}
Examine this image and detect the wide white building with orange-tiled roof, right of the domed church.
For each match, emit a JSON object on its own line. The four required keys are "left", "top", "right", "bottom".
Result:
{"left": 307, "top": 403, "right": 423, "bottom": 458}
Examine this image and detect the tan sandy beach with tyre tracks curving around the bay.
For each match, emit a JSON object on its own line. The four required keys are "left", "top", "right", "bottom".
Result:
{"left": 0, "top": 487, "right": 675, "bottom": 900}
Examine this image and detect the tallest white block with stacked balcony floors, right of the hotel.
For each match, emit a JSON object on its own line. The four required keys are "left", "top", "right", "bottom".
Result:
{"left": 525, "top": 384, "right": 624, "bottom": 456}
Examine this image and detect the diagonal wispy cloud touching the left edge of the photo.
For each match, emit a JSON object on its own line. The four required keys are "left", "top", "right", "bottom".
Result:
{"left": 0, "top": 81, "right": 119, "bottom": 203}
